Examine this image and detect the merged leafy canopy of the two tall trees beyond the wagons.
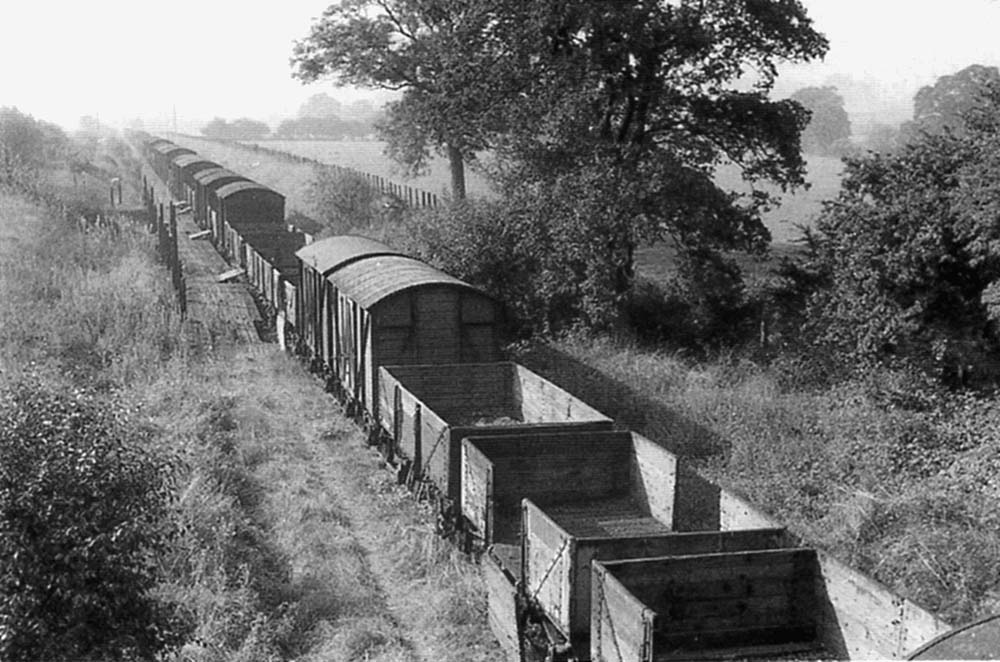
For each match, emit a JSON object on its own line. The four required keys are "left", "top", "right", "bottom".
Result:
{"left": 293, "top": 0, "right": 827, "bottom": 330}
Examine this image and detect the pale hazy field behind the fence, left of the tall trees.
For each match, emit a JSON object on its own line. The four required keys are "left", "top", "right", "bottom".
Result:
{"left": 243, "top": 140, "right": 489, "bottom": 196}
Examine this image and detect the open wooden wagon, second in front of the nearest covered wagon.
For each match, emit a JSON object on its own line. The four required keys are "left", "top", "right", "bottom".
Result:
{"left": 461, "top": 426, "right": 677, "bottom": 545}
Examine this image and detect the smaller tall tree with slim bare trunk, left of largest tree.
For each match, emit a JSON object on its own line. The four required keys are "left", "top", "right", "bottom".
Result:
{"left": 292, "top": 0, "right": 544, "bottom": 200}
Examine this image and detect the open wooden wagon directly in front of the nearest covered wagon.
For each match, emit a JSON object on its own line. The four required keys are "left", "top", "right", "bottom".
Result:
{"left": 376, "top": 362, "right": 614, "bottom": 505}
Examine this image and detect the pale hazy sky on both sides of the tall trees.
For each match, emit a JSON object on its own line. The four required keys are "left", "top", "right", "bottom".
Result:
{"left": 0, "top": 0, "right": 1000, "bottom": 129}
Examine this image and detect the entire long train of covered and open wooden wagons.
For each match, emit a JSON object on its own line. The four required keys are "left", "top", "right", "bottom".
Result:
{"left": 132, "top": 132, "right": 948, "bottom": 662}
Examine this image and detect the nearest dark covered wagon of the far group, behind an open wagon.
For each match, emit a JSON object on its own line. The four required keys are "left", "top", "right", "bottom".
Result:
{"left": 209, "top": 181, "right": 285, "bottom": 255}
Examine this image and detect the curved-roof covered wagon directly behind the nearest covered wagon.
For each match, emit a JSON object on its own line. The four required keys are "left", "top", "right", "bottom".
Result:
{"left": 295, "top": 235, "right": 402, "bottom": 366}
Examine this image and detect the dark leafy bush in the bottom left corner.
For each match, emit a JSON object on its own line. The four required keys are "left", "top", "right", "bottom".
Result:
{"left": 0, "top": 381, "right": 176, "bottom": 660}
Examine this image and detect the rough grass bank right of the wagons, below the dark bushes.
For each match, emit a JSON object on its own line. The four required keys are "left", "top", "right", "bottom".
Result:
{"left": 520, "top": 338, "right": 1000, "bottom": 623}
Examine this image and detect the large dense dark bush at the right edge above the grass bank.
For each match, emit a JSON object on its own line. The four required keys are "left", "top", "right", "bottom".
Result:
{"left": 792, "top": 83, "right": 1000, "bottom": 383}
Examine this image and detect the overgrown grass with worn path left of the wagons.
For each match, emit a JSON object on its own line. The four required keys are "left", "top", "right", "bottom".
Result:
{"left": 0, "top": 158, "right": 497, "bottom": 662}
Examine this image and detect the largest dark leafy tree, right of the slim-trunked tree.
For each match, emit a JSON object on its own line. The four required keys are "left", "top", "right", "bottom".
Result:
{"left": 480, "top": 0, "right": 826, "bottom": 322}
